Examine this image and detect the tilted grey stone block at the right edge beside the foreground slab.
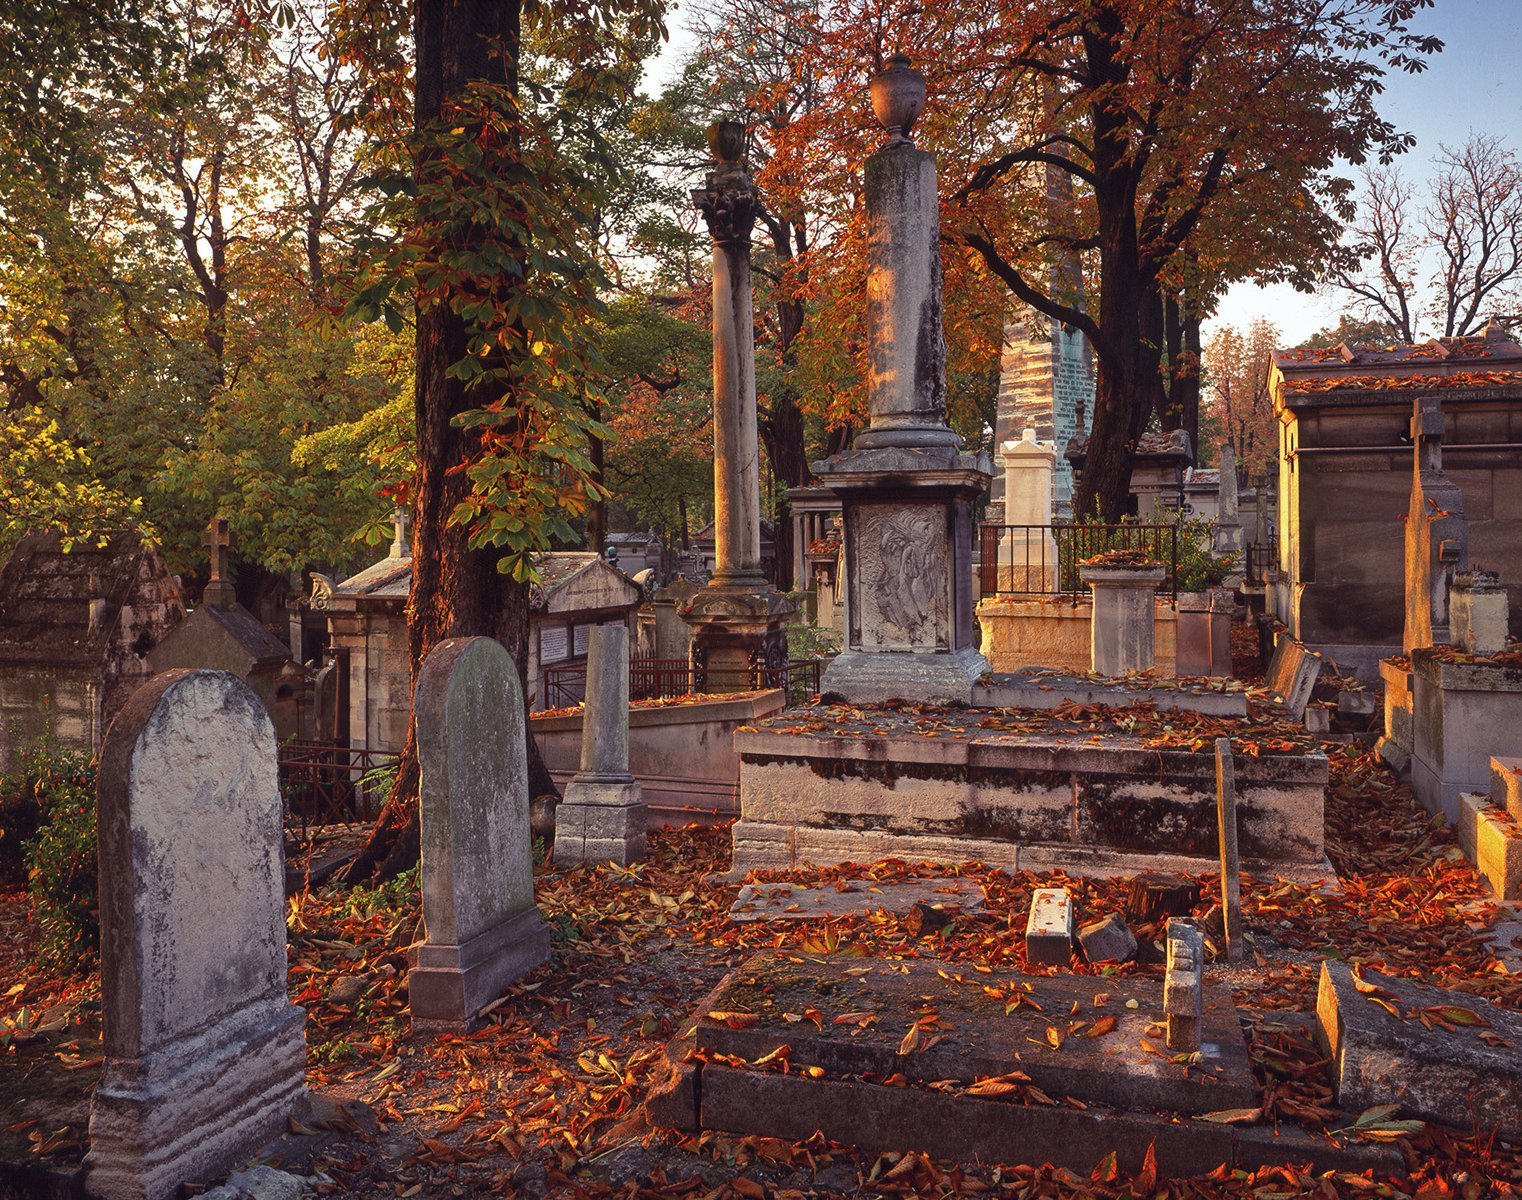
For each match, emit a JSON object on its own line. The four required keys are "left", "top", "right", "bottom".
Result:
{"left": 1317, "top": 961, "right": 1522, "bottom": 1142}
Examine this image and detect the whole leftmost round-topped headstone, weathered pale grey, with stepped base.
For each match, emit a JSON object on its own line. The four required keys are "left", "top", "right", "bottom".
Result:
{"left": 87, "top": 670, "right": 307, "bottom": 1200}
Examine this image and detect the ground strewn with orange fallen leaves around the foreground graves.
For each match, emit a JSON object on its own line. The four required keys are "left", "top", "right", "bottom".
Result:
{"left": 0, "top": 746, "right": 1522, "bottom": 1200}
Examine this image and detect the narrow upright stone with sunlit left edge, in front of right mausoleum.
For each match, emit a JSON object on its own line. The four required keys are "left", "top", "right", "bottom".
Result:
{"left": 1402, "top": 396, "right": 1469, "bottom": 655}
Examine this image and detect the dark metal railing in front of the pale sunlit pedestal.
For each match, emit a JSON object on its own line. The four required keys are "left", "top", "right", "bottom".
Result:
{"left": 979, "top": 524, "right": 1178, "bottom": 603}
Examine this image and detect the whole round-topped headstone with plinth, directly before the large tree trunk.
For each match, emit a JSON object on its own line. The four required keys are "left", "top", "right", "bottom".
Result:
{"left": 408, "top": 638, "right": 549, "bottom": 1031}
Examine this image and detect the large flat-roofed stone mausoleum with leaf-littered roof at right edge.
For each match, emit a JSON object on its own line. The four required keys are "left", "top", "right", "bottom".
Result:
{"left": 1269, "top": 324, "right": 1522, "bottom": 679}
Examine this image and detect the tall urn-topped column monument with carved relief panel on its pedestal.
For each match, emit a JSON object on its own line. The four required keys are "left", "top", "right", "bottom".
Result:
{"left": 814, "top": 55, "right": 992, "bottom": 704}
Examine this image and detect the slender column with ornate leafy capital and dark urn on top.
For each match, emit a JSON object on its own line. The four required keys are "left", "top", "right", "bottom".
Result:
{"left": 682, "top": 120, "right": 793, "bottom": 687}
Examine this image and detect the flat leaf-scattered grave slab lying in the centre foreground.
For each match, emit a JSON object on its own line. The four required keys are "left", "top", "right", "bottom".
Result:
{"left": 694, "top": 953, "right": 1260, "bottom": 1114}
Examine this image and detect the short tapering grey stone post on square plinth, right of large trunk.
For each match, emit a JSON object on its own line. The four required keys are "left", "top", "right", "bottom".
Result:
{"left": 556, "top": 624, "right": 645, "bottom": 866}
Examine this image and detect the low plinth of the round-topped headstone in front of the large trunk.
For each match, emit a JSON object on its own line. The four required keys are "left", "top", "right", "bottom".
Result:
{"left": 406, "top": 908, "right": 549, "bottom": 1032}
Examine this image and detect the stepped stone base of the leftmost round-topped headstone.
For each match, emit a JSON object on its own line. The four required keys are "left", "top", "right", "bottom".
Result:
{"left": 85, "top": 997, "right": 309, "bottom": 1200}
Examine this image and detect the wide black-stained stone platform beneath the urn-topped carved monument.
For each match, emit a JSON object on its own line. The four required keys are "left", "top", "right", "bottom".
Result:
{"left": 732, "top": 707, "right": 1332, "bottom": 880}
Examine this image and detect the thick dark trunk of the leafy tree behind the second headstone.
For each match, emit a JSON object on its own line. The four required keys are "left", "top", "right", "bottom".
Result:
{"left": 344, "top": 0, "right": 556, "bottom": 883}
